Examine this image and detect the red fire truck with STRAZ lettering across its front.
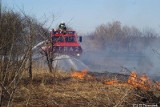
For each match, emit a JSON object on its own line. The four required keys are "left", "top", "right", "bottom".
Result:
{"left": 51, "top": 30, "right": 82, "bottom": 56}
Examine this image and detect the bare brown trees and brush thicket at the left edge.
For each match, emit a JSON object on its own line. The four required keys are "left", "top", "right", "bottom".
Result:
{"left": 0, "top": 7, "right": 48, "bottom": 106}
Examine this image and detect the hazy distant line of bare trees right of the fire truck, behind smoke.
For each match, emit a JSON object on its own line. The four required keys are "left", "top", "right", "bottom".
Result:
{"left": 87, "top": 21, "right": 160, "bottom": 52}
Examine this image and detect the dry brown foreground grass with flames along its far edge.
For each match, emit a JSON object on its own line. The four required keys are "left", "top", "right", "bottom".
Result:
{"left": 3, "top": 70, "right": 160, "bottom": 107}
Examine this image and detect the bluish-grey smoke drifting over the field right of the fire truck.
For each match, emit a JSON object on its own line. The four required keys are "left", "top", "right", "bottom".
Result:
{"left": 80, "top": 36, "right": 160, "bottom": 79}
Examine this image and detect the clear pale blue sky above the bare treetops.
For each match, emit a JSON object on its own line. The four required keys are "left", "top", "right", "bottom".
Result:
{"left": 2, "top": 0, "right": 160, "bottom": 33}
